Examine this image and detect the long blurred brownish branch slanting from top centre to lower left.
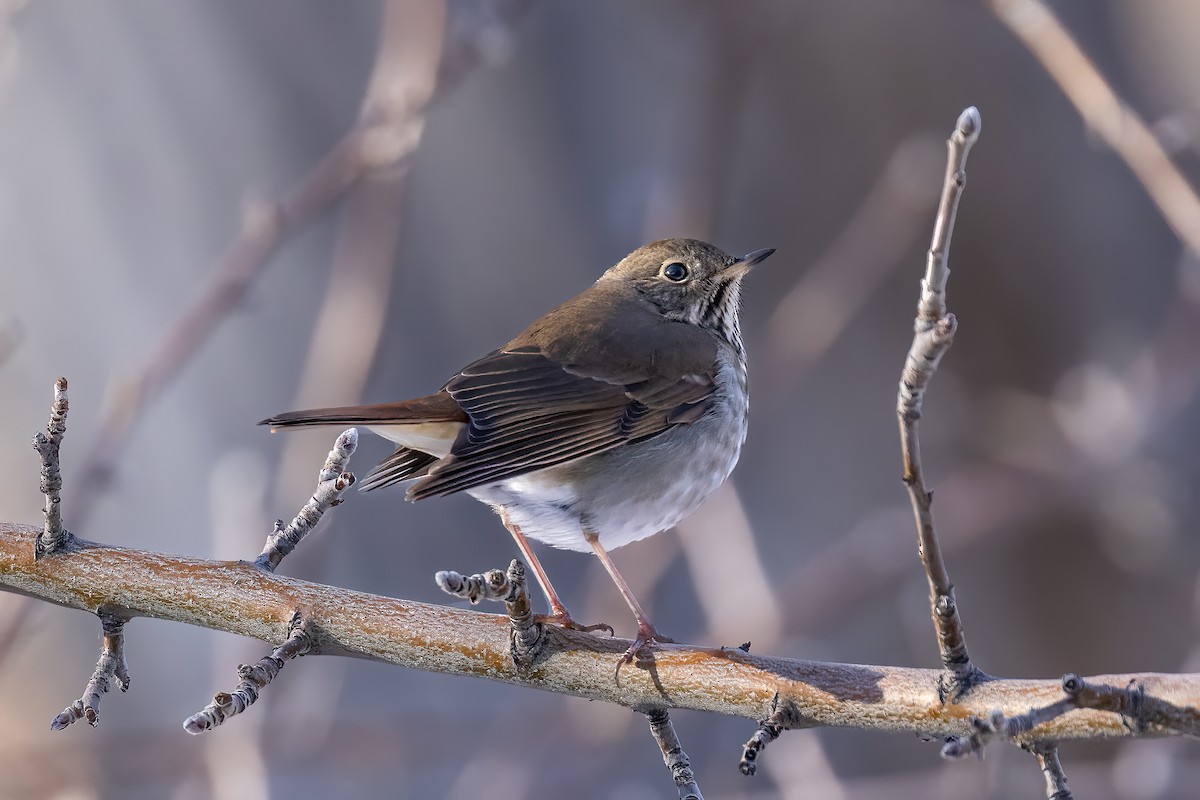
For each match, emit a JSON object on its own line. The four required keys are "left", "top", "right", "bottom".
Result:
{"left": 65, "top": 0, "right": 530, "bottom": 524}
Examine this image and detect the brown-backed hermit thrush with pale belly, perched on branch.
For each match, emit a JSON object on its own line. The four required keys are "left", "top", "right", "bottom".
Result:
{"left": 262, "top": 239, "right": 775, "bottom": 661}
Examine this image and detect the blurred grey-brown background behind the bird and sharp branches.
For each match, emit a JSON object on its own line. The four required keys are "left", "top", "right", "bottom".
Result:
{"left": 0, "top": 0, "right": 1200, "bottom": 800}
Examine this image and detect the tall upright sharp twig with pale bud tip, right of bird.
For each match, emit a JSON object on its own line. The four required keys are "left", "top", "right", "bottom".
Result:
{"left": 896, "top": 106, "right": 983, "bottom": 699}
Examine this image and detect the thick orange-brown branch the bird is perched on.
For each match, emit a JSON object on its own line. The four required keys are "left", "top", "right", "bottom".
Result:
{"left": 0, "top": 523, "right": 1200, "bottom": 741}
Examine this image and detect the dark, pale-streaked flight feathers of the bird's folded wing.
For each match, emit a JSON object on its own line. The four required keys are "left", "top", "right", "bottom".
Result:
{"left": 408, "top": 347, "right": 715, "bottom": 500}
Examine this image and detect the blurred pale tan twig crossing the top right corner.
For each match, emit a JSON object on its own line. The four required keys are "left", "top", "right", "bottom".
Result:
{"left": 990, "top": 0, "right": 1200, "bottom": 254}
